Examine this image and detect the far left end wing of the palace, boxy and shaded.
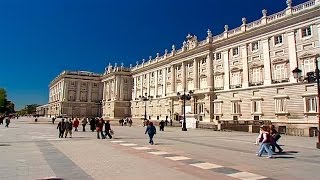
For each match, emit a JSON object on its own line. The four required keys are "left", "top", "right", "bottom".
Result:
{"left": 48, "top": 71, "right": 103, "bottom": 117}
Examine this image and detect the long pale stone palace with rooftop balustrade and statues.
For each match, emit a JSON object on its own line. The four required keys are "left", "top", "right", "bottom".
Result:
{"left": 50, "top": 0, "right": 320, "bottom": 132}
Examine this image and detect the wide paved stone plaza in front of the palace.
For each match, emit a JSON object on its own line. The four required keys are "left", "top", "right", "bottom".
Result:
{"left": 0, "top": 118, "right": 320, "bottom": 180}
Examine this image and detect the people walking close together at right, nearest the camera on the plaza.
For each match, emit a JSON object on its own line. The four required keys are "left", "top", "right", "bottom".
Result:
{"left": 255, "top": 125, "right": 283, "bottom": 158}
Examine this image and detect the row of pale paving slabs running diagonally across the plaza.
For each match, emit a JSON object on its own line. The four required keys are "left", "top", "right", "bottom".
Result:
{"left": 111, "top": 141, "right": 270, "bottom": 180}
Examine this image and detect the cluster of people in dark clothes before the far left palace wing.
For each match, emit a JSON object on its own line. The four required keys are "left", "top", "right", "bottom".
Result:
{"left": 56, "top": 118, "right": 113, "bottom": 139}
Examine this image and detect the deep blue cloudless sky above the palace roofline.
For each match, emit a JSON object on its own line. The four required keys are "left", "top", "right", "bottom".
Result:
{"left": 0, "top": 0, "right": 305, "bottom": 109}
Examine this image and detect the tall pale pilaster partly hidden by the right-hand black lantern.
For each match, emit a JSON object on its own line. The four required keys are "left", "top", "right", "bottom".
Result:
{"left": 288, "top": 31, "right": 298, "bottom": 82}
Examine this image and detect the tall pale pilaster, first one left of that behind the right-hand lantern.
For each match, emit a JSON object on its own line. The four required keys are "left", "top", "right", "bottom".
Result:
{"left": 262, "top": 38, "right": 271, "bottom": 85}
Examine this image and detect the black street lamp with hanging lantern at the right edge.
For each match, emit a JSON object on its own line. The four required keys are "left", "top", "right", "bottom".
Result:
{"left": 292, "top": 55, "right": 320, "bottom": 149}
